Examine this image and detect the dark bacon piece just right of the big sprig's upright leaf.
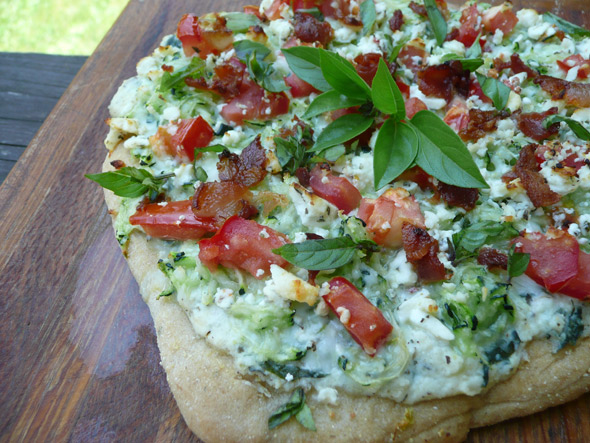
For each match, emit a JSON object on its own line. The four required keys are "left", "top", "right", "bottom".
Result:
{"left": 418, "top": 60, "right": 469, "bottom": 102}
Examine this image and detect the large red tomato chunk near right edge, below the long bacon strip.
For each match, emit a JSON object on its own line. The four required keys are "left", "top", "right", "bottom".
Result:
{"left": 513, "top": 228, "right": 580, "bottom": 292}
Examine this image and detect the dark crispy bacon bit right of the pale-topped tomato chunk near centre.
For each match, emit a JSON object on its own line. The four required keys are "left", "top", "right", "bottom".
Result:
{"left": 402, "top": 222, "right": 446, "bottom": 281}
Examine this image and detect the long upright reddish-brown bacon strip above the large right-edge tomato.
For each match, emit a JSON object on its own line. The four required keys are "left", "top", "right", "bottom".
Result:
{"left": 514, "top": 143, "right": 561, "bottom": 208}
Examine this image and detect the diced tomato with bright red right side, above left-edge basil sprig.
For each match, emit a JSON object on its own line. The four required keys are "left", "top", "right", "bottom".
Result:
{"left": 150, "top": 116, "right": 214, "bottom": 162}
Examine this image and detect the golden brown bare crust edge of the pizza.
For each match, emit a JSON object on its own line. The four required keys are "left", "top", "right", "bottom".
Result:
{"left": 103, "top": 144, "right": 590, "bottom": 441}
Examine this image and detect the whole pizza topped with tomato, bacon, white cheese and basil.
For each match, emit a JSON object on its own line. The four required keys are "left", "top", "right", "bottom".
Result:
{"left": 88, "top": 0, "right": 590, "bottom": 441}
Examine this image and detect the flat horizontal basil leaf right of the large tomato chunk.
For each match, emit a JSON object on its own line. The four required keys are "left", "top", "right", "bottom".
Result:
{"left": 272, "top": 237, "right": 358, "bottom": 271}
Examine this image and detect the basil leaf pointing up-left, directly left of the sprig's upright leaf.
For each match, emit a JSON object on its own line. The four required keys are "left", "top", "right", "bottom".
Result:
{"left": 319, "top": 49, "right": 371, "bottom": 100}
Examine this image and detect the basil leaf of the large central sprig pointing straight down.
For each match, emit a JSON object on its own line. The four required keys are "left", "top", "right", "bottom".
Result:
{"left": 373, "top": 119, "right": 418, "bottom": 190}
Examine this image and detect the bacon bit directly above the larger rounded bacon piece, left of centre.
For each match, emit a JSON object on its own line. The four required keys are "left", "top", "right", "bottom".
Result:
{"left": 217, "top": 137, "right": 266, "bottom": 188}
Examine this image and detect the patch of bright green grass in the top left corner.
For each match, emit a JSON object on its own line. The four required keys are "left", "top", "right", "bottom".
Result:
{"left": 0, "top": 0, "right": 127, "bottom": 55}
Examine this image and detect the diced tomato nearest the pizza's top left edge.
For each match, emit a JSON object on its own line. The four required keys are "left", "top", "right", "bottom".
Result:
{"left": 176, "top": 14, "right": 234, "bottom": 59}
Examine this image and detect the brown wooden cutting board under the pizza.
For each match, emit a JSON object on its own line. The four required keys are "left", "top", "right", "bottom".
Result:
{"left": 0, "top": 0, "right": 590, "bottom": 442}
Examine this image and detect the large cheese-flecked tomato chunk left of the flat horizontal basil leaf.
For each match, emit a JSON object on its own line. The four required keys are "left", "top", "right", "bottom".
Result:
{"left": 199, "top": 215, "right": 289, "bottom": 279}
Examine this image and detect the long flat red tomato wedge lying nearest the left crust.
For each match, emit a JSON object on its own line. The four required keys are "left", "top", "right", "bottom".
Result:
{"left": 129, "top": 200, "right": 218, "bottom": 240}
